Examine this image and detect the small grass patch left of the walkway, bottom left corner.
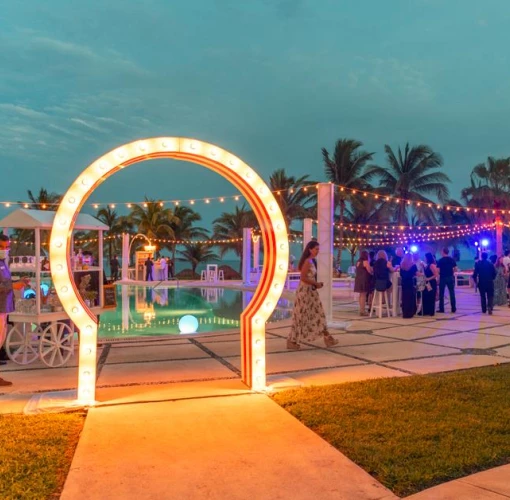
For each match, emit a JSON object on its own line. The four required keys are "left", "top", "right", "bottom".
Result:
{"left": 0, "top": 413, "right": 85, "bottom": 500}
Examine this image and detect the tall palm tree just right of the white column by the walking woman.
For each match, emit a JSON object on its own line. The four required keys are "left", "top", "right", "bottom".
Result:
{"left": 322, "top": 139, "right": 375, "bottom": 266}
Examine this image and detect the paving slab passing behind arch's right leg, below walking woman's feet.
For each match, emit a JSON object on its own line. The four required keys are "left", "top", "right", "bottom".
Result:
{"left": 228, "top": 349, "right": 362, "bottom": 373}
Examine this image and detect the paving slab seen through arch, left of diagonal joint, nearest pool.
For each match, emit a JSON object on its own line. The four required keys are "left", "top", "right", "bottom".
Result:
{"left": 106, "top": 342, "right": 209, "bottom": 365}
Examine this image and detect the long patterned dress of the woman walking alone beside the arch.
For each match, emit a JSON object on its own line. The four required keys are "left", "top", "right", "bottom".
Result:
{"left": 288, "top": 262, "right": 328, "bottom": 344}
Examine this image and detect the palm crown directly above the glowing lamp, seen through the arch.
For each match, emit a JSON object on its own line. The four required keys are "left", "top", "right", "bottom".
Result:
{"left": 129, "top": 197, "right": 178, "bottom": 246}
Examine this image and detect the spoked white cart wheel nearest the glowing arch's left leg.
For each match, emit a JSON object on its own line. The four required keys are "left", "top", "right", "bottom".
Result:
{"left": 39, "top": 321, "right": 74, "bottom": 367}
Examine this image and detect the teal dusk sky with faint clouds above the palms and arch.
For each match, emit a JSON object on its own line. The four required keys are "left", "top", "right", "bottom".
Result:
{"left": 0, "top": 0, "right": 510, "bottom": 227}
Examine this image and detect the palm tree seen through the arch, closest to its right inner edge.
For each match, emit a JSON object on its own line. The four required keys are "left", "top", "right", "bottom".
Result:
{"left": 213, "top": 203, "right": 256, "bottom": 272}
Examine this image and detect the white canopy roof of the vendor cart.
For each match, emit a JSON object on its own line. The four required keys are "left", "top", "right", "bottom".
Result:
{"left": 0, "top": 208, "right": 109, "bottom": 231}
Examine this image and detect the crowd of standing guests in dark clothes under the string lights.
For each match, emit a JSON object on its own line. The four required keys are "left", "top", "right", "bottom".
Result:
{"left": 354, "top": 247, "right": 510, "bottom": 318}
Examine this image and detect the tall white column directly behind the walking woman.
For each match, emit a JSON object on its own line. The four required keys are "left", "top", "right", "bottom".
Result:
{"left": 317, "top": 182, "right": 334, "bottom": 322}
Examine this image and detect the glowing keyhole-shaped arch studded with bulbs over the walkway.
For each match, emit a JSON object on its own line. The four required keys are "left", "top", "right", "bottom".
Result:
{"left": 50, "top": 137, "right": 289, "bottom": 404}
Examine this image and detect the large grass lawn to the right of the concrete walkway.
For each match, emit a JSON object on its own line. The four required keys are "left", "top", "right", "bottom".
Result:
{"left": 274, "top": 365, "right": 510, "bottom": 496}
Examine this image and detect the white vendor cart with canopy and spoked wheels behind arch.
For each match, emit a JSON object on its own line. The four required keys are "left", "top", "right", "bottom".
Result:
{"left": 0, "top": 209, "right": 109, "bottom": 367}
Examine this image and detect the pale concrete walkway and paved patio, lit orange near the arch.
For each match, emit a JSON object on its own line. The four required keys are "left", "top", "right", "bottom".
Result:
{"left": 0, "top": 289, "right": 510, "bottom": 500}
